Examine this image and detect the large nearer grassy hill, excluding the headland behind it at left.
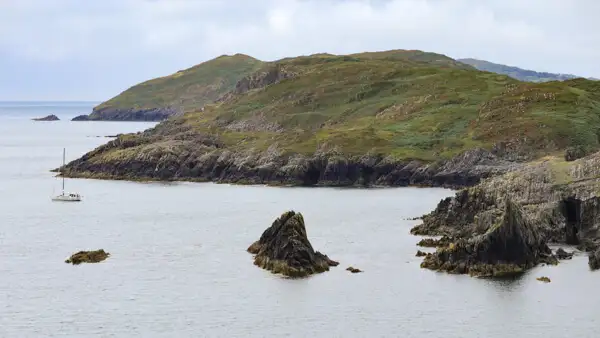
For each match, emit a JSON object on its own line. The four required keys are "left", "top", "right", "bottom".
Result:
{"left": 62, "top": 51, "right": 600, "bottom": 186}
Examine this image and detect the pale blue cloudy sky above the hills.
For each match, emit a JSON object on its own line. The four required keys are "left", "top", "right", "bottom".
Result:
{"left": 0, "top": 0, "right": 600, "bottom": 101}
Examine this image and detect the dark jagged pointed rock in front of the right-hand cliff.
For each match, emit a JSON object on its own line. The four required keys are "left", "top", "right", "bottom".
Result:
{"left": 421, "top": 199, "right": 557, "bottom": 277}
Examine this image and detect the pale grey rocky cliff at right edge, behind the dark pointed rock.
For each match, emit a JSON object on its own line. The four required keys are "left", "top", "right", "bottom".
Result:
{"left": 411, "top": 153, "right": 600, "bottom": 265}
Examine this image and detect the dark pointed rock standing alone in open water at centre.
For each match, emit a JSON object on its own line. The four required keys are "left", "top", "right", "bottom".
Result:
{"left": 248, "top": 211, "right": 339, "bottom": 277}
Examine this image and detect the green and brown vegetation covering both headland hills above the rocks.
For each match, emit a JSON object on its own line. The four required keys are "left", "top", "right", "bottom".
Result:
{"left": 92, "top": 51, "right": 600, "bottom": 161}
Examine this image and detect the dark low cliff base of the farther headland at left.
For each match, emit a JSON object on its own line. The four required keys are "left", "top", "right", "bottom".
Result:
{"left": 71, "top": 108, "right": 181, "bottom": 122}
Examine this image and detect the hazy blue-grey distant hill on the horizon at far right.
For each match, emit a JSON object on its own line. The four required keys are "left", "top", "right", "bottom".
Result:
{"left": 457, "top": 58, "right": 596, "bottom": 82}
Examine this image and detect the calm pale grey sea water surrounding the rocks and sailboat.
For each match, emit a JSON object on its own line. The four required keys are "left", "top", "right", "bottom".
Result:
{"left": 0, "top": 103, "right": 600, "bottom": 338}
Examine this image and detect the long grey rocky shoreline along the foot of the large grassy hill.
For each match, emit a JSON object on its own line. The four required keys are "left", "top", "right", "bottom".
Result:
{"left": 58, "top": 131, "right": 522, "bottom": 189}
